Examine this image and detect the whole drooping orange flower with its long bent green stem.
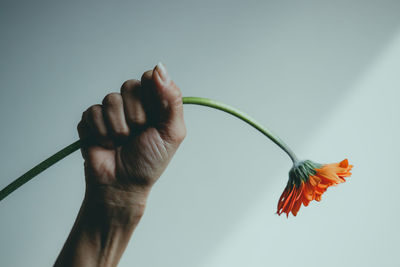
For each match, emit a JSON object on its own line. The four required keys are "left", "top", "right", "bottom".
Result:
{"left": 0, "top": 94, "right": 353, "bottom": 220}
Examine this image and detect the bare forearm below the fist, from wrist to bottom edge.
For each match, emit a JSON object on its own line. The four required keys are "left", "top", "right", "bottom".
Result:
{"left": 54, "top": 188, "right": 147, "bottom": 267}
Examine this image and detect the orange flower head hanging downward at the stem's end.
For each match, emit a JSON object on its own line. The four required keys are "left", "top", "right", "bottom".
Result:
{"left": 277, "top": 159, "right": 353, "bottom": 217}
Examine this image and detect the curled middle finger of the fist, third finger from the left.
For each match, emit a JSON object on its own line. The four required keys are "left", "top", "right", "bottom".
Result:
{"left": 121, "top": 80, "right": 146, "bottom": 131}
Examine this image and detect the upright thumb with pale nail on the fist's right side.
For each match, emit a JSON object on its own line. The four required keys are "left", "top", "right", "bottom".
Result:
{"left": 151, "top": 62, "right": 186, "bottom": 144}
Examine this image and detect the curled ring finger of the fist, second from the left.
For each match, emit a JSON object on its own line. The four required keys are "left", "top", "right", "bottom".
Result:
{"left": 103, "top": 93, "right": 130, "bottom": 143}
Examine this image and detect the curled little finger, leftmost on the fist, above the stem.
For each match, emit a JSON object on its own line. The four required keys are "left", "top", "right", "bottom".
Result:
{"left": 82, "top": 105, "right": 113, "bottom": 148}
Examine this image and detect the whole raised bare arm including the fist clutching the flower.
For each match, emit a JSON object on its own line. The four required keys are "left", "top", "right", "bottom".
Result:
{"left": 54, "top": 64, "right": 186, "bottom": 267}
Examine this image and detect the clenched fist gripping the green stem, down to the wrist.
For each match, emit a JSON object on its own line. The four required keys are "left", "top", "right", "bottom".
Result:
{"left": 78, "top": 63, "right": 186, "bottom": 205}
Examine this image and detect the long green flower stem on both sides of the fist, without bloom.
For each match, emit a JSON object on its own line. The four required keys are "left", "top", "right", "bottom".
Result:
{"left": 0, "top": 97, "right": 298, "bottom": 201}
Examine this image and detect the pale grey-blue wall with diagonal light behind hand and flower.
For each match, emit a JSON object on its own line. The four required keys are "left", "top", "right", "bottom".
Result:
{"left": 0, "top": 0, "right": 400, "bottom": 267}
